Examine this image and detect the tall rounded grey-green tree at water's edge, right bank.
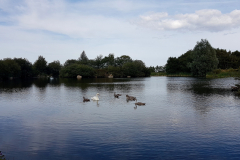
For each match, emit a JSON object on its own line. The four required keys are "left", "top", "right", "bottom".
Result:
{"left": 190, "top": 39, "right": 218, "bottom": 77}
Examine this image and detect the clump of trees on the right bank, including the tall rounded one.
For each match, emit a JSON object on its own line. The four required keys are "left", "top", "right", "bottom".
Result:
{"left": 164, "top": 39, "right": 240, "bottom": 76}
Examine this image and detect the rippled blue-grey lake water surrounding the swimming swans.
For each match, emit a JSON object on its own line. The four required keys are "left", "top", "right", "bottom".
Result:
{"left": 0, "top": 77, "right": 240, "bottom": 160}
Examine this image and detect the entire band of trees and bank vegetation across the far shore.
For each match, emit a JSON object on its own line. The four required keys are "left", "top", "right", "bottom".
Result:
{"left": 0, "top": 39, "right": 240, "bottom": 80}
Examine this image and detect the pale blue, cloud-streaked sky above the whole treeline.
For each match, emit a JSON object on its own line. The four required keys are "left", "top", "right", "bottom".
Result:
{"left": 0, "top": 0, "right": 240, "bottom": 66}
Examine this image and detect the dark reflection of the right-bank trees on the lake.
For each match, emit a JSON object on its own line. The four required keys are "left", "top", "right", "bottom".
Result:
{"left": 167, "top": 78, "right": 232, "bottom": 114}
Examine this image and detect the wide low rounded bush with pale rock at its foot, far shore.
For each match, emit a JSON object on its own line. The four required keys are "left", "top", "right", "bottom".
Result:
{"left": 60, "top": 64, "right": 95, "bottom": 78}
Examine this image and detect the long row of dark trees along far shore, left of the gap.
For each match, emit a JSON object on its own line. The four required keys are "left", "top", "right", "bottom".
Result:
{"left": 0, "top": 51, "right": 151, "bottom": 79}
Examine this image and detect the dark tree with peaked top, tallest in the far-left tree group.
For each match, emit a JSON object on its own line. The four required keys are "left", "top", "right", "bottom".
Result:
{"left": 33, "top": 56, "right": 47, "bottom": 75}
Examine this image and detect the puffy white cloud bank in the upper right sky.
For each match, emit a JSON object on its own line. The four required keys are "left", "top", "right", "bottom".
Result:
{"left": 134, "top": 9, "right": 240, "bottom": 32}
